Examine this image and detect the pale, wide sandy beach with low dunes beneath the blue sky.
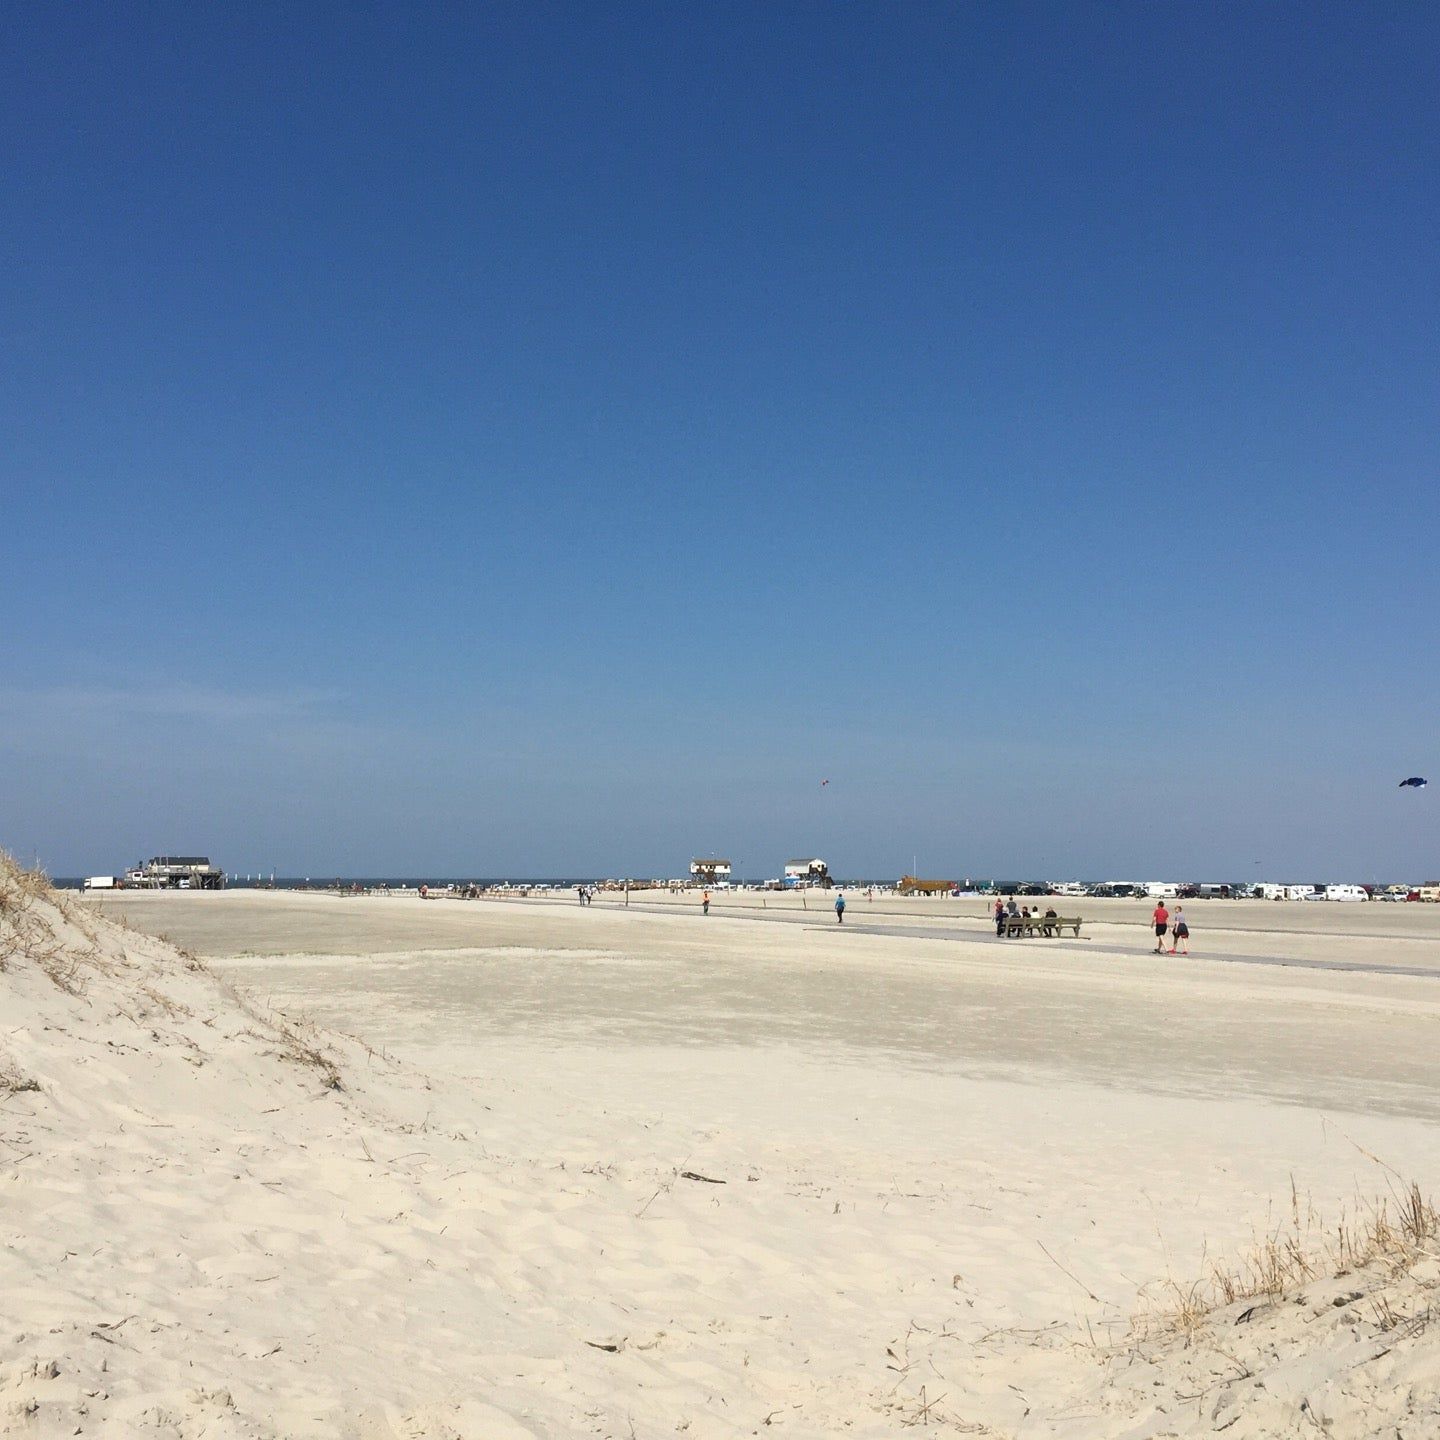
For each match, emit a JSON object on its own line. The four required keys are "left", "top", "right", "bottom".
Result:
{"left": 8, "top": 869, "right": 1440, "bottom": 1437}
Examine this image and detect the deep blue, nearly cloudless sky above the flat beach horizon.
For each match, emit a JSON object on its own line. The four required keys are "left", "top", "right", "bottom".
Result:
{"left": 0, "top": 3, "right": 1440, "bottom": 880}
